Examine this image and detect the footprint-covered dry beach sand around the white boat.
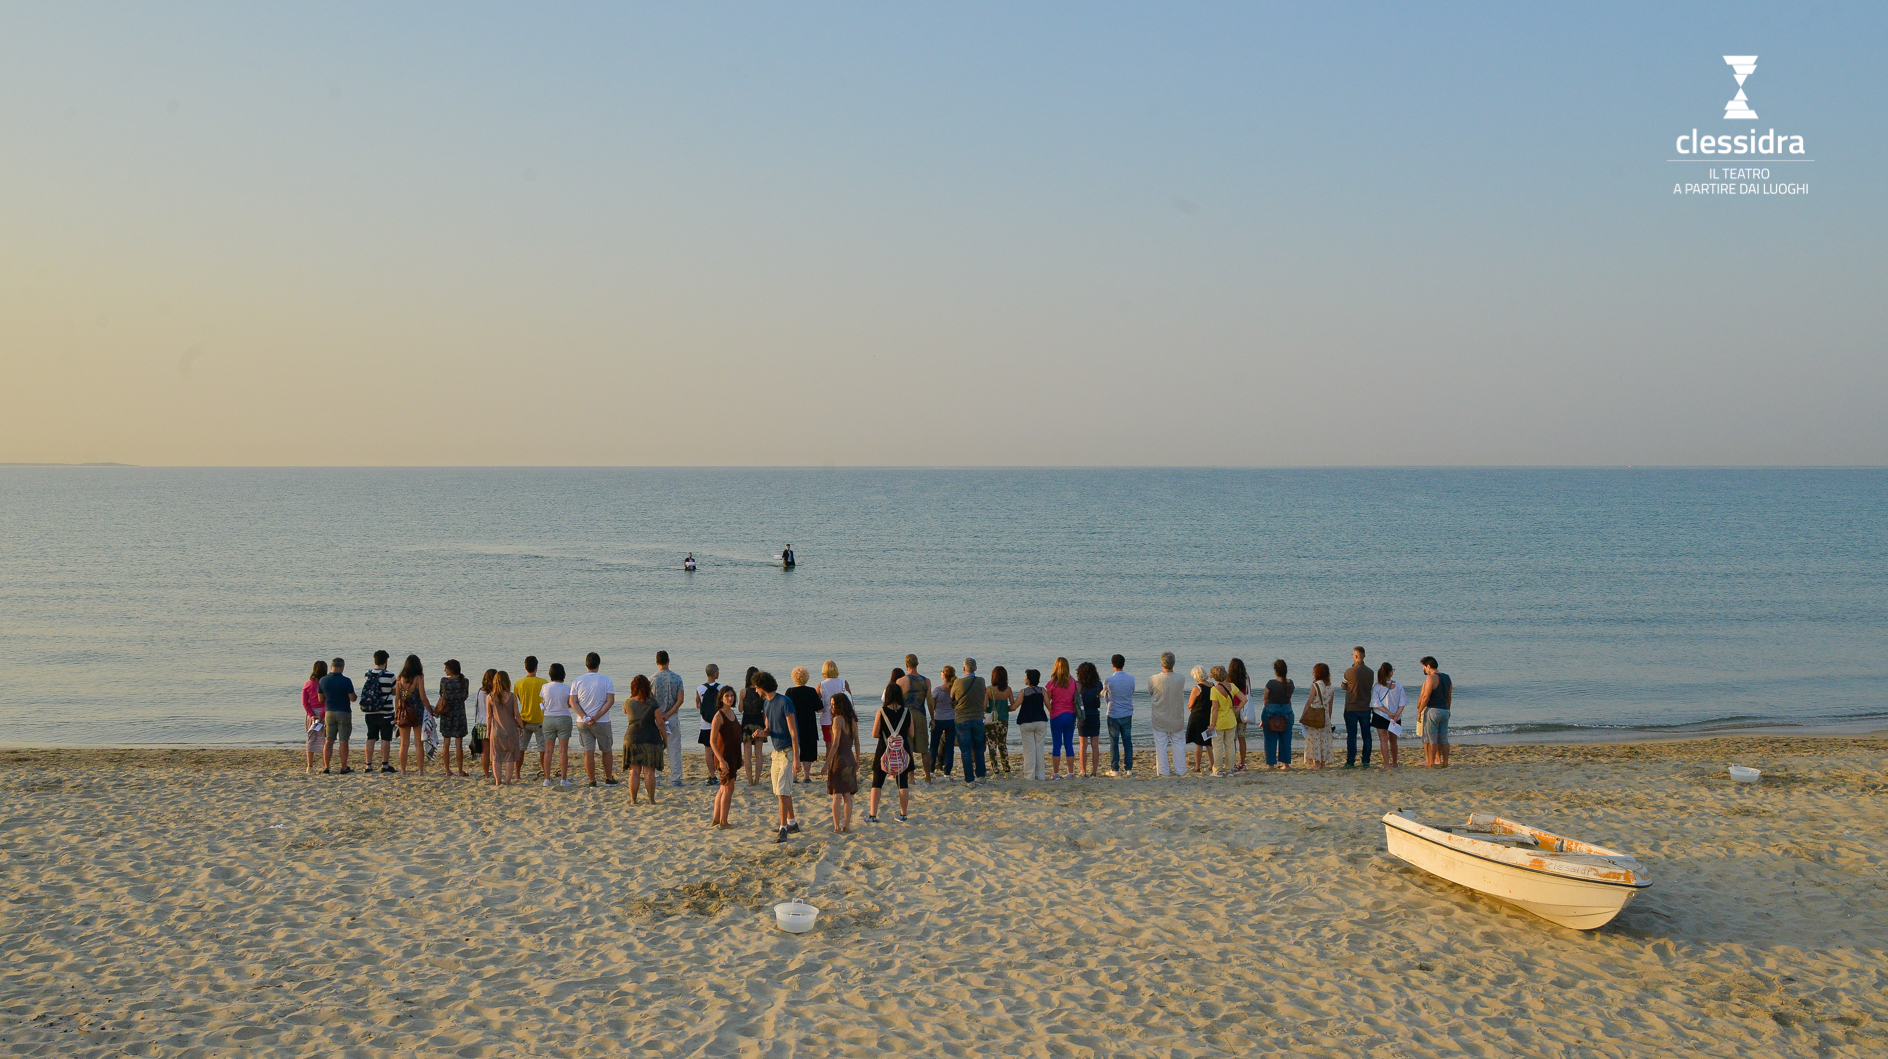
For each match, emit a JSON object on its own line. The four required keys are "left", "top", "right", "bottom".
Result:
{"left": 0, "top": 738, "right": 1888, "bottom": 1057}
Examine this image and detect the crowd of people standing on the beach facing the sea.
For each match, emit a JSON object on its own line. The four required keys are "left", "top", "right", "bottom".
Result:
{"left": 302, "top": 647, "right": 1454, "bottom": 842}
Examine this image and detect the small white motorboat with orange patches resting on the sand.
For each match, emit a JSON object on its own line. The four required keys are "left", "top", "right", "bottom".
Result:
{"left": 1384, "top": 810, "right": 1652, "bottom": 931}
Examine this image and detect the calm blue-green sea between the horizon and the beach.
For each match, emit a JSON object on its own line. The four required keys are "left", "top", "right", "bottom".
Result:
{"left": 0, "top": 468, "right": 1888, "bottom": 746}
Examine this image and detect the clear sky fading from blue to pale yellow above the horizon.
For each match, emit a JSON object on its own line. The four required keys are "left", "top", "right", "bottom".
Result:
{"left": 0, "top": 2, "right": 1888, "bottom": 466}
